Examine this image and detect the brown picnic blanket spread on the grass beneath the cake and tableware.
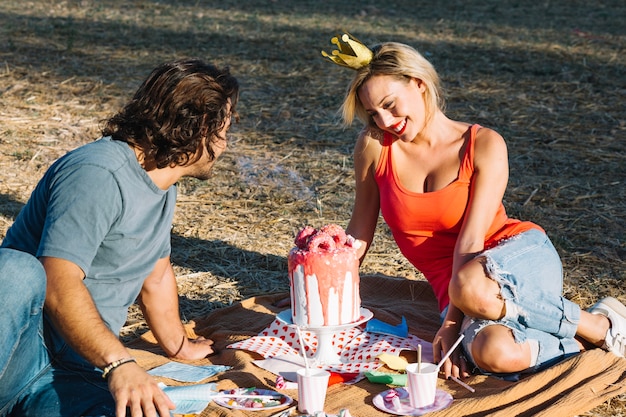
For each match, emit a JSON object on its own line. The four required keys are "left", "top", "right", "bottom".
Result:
{"left": 128, "top": 275, "right": 626, "bottom": 417}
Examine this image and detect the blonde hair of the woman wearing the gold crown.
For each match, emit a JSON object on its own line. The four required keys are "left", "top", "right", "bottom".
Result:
{"left": 341, "top": 42, "right": 444, "bottom": 126}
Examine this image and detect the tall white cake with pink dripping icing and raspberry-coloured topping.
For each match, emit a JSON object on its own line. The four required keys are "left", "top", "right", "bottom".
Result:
{"left": 288, "top": 224, "right": 361, "bottom": 327}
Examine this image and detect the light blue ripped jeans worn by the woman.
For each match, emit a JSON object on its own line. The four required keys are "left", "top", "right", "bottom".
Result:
{"left": 462, "top": 229, "right": 580, "bottom": 373}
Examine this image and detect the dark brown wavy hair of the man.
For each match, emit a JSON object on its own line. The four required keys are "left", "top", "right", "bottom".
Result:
{"left": 102, "top": 58, "right": 239, "bottom": 168}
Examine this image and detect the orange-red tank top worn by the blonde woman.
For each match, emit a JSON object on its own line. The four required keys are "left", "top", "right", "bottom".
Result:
{"left": 375, "top": 125, "right": 542, "bottom": 311}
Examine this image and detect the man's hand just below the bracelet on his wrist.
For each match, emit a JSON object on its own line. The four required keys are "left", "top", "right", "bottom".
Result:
{"left": 107, "top": 362, "right": 175, "bottom": 417}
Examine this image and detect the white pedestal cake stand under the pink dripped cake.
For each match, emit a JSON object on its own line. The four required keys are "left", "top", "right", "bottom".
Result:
{"left": 276, "top": 307, "right": 374, "bottom": 365}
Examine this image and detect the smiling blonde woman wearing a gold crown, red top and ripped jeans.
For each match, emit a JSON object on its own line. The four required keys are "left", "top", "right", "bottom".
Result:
{"left": 322, "top": 34, "right": 626, "bottom": 378}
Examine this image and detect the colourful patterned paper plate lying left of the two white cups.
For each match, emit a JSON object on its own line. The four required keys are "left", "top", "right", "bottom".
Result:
{"left": 213, "top": 388, "right": 293, "bottom": 411}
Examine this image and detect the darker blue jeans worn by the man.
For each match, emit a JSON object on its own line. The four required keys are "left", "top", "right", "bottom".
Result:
{"left": 0, "top": 248, "right": 115, "bottom": 417}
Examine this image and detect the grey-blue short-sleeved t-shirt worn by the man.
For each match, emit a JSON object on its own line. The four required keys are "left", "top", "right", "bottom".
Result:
{"left": 2, "top": 138, "right": 176, "bottom": 334}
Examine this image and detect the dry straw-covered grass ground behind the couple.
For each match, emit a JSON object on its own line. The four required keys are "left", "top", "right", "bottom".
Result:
{"left": 0, "top": 0, "right": 626, "bottom": 417}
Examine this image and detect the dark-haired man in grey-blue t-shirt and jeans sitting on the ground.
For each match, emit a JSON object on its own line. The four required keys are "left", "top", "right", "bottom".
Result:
{"left": 0, "top": 59, "right": 239, "bottom": 417}
